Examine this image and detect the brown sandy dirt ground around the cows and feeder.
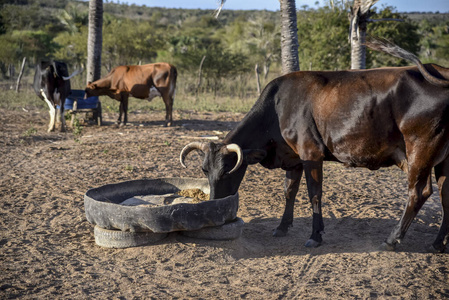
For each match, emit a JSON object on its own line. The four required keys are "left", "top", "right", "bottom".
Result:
{"left": 0, "top": 106, "right": 449, "bottom": 299}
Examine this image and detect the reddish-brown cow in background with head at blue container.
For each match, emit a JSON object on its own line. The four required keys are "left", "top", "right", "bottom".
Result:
{"left": 85, "top": 63, "right": 178, "bottom": 126}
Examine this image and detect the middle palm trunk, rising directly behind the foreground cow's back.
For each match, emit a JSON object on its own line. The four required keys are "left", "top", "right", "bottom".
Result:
{"left": 279, "top": 0, "right": 299, "bottom": 74}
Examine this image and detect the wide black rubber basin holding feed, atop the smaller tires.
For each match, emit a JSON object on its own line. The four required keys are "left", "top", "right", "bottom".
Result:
{"left": 84, "top": 178, "right": 239, "bottom": 233}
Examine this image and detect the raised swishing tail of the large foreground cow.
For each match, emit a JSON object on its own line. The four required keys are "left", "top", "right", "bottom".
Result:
{"left": 365, "top": 36, "right": 449, "bottom": 87}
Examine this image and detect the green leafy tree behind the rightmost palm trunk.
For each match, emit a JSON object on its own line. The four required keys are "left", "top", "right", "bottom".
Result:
{"left": 298, "top": 6, "right": 420, "bottom": 70}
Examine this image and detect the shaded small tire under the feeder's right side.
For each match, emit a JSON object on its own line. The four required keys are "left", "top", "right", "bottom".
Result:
{"left": 181, "top": 218, "right": 245, "bottom": 240}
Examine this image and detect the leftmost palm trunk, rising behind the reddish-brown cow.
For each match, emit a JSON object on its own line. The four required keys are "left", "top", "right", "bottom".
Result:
{"left": 87, "top": 0, "right": 103, "bottom": 82}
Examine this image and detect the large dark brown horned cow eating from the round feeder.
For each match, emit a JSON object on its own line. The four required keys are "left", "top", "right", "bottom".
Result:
{"left": 180, "top": 41, "right": 449, "bottom": 252}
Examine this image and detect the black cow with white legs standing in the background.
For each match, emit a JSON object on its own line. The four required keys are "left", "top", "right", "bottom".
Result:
{"left": 33, "top": 61, "right": 81, "bottom": 132}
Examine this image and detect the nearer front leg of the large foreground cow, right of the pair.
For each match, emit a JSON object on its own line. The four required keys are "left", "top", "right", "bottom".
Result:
{"left": 304, "top": 161, "right": 324, "bottom": 247}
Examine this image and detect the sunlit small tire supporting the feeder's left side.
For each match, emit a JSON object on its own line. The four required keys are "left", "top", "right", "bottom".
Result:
{"left": 94, "top": 226, "right": 167, "bottom": 248}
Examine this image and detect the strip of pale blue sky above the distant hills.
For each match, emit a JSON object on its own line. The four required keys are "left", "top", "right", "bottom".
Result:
{"left": 104, "top": 0, "right": 449, "bottom": 13}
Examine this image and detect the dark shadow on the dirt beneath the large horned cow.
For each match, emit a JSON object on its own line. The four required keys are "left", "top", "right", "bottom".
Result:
{"left": 172, "top": 217, "right": 440, "bottom": 259}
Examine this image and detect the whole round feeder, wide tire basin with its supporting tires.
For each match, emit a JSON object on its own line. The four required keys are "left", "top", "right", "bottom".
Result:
{"left": 84, "top": 178, "right": 243, "bottom": 248}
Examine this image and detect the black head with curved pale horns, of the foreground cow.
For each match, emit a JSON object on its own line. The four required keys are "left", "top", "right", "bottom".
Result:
{"left": 180, "top": 142, "right": 266, "bottom": 199}
